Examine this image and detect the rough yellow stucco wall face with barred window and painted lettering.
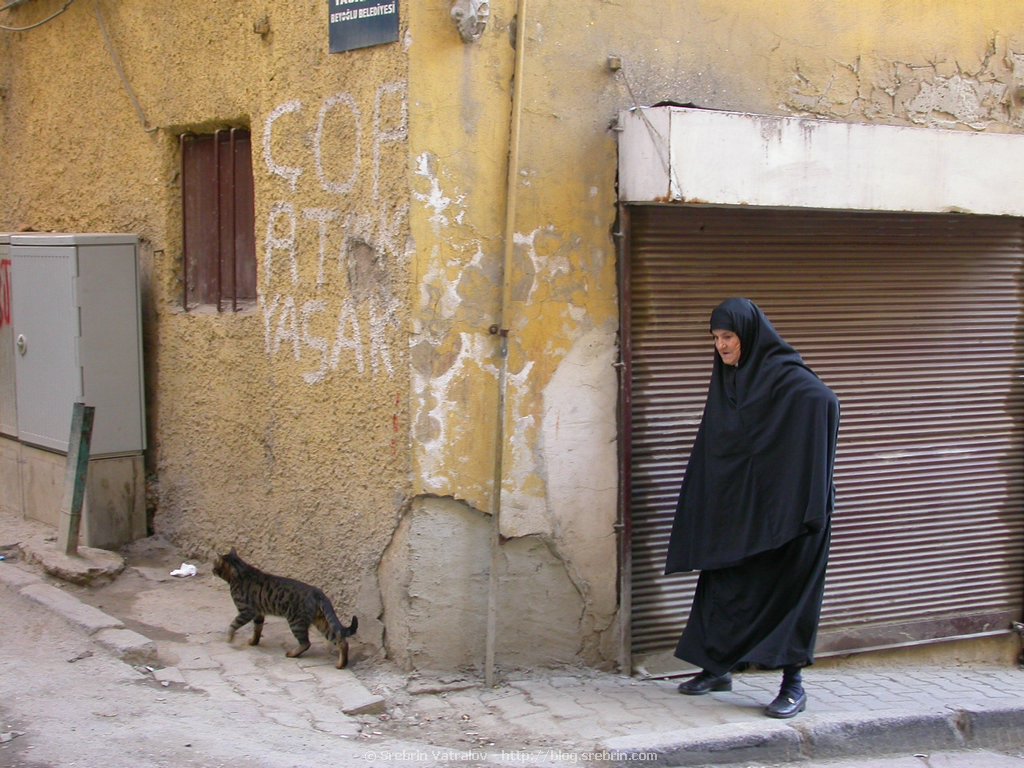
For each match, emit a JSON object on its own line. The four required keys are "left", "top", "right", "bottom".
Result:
{"left": 0, "top": 0, "right": 412, "bottom": 652}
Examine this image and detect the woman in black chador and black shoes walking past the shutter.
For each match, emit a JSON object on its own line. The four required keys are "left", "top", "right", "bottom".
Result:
{"left": 665, "top": 299, "right": 839, "bottom": 718}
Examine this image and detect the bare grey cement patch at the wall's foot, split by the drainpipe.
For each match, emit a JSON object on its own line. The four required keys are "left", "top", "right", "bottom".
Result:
{"left": 381, "top": 498, "right": 584, "bottom": 671}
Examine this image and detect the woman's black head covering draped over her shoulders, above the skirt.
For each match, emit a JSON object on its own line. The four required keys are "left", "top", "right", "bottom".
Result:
{"left": 665, "top": 299, "right": 839, "bottom": 573}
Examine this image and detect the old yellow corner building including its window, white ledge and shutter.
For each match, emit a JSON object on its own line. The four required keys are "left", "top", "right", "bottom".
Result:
{"left": 0, "top": 0, "right": 1024, "bottom": 671}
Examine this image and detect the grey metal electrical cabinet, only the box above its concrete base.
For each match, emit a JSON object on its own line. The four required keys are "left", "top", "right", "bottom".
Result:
{"left": 9, "top": 232, "right": 145, "bottom": 458}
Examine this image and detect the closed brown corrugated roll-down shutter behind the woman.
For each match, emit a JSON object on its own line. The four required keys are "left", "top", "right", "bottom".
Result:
{"left": 624, "top": 206, "right": 1024, "bottom": 657}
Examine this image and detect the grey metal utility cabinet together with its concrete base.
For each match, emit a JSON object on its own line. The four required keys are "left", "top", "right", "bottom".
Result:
{"left": 0, "top": 232, "right": 146, "bottom": 547}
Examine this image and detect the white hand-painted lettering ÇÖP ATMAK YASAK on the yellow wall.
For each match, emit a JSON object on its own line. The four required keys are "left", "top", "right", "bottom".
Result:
{"left": 260, "top": 83, "right": 409, "bottom": 385}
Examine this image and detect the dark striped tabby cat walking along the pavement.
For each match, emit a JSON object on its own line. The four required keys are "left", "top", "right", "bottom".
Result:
{"left": 213, "top": 547, "right": 359, "bottom": 670}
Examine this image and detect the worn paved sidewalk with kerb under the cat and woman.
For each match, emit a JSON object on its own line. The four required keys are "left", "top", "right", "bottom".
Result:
{"left": 0, "top": 507, "right": 1024, "bottom": 766}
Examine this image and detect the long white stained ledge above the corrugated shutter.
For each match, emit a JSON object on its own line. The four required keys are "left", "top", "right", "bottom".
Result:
{"left": 618, "top": 106, "right": 1024, "bottom": 216}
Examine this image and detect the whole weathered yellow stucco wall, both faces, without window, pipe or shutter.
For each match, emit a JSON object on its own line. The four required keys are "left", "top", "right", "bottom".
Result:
{"left": 6, "top": 0, "right": 1024, "bottom": 667}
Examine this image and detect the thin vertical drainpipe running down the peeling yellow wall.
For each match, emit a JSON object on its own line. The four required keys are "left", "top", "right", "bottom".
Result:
{"left": 483, "top": 0, "right": 526, "bottom": 687}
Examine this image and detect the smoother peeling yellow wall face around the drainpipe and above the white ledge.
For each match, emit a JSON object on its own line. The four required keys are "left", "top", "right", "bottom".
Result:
{"left": 401, "top": 0, "right": 1024, "bottom": 664}
